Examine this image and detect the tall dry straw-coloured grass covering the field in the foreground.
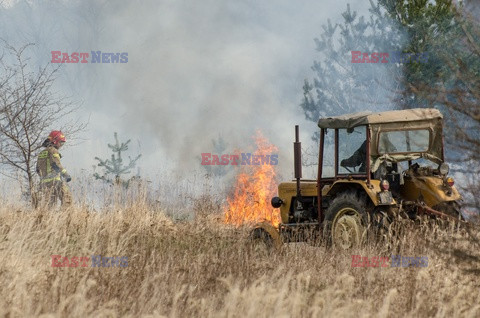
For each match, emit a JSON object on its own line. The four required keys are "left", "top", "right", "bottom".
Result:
{"left": 0, "top": 196, "right": 480, "bottom": 317}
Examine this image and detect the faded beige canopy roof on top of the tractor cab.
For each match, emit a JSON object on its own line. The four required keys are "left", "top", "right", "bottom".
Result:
{"left": 318, "top": 108, "right": 443, "bottom": 129}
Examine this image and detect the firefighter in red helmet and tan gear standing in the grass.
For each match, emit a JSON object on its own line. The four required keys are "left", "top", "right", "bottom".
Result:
{"left": 36, "top": 130, "right": 72, "bottom": 207}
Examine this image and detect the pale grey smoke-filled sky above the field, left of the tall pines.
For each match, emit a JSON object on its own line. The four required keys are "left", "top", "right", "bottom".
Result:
{"left": 0, "top": 0, "right": 370, "bottom": 180}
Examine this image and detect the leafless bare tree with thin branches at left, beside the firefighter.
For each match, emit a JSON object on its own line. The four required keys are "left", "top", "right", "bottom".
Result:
{"left": 0, "top": 40, "right": 86, "bottom": 202}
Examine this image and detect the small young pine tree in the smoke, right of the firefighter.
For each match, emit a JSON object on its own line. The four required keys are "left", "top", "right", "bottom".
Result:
{"left": 93, "top": 132, "right": 142, "bottom": 188}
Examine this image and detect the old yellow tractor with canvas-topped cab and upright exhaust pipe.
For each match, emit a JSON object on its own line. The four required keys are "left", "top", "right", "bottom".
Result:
{"left": 252, "top": 109, "right": 463, "bottom": 248}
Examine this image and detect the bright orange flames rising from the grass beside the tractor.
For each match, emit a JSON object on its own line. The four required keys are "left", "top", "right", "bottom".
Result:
{"left": 224, "top": 131, "right": 280, "bottom": 227}
